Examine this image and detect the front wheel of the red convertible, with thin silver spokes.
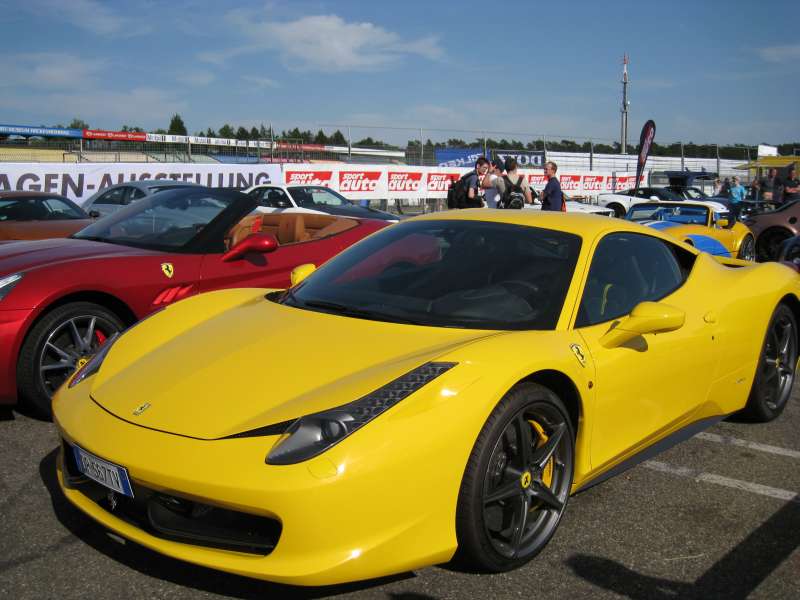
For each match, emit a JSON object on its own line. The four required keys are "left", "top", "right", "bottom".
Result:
{"left": 17, "top": 302, "right": 125, "bottom": 419}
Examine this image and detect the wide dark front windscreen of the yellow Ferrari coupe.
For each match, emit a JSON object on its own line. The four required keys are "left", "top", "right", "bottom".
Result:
{"left": 285, "top": 220, "right": 581, "bottom": 330}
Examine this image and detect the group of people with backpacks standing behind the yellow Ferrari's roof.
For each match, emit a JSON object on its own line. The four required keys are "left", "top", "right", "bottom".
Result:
{"left": 448, "top": 157, "right": 566, "bottom": 211}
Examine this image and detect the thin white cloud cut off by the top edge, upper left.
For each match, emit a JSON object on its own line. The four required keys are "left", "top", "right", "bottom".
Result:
{"left": 25, "top": 0, "right": 150, "bottom": 37}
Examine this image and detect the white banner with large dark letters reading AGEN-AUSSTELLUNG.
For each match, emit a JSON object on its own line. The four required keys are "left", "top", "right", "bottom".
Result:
{"left": 0, "top": 163, "right": 283, "bottom": 203}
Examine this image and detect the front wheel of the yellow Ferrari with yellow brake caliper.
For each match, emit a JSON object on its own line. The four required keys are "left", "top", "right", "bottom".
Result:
{"left": 456, "top": 383, "right": 575, "bottom": 573}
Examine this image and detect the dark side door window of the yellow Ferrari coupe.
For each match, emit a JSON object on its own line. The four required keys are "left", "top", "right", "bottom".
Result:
{"left": 575, "top": 232, "right": 694, "bottom": 327}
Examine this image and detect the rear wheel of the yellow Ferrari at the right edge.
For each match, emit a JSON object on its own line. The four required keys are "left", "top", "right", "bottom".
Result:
{"left": 743, "top": 304, "right": 798, "bottom": 423}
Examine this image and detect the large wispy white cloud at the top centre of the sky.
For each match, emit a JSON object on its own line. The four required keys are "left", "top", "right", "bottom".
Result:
{"left": 199, "top": 9, "right": 442, "bottom": 72}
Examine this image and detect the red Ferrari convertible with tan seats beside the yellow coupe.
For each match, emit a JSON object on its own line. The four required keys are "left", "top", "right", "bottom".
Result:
{"left": 0, "top": 188, "right": 386, "bottom": 417}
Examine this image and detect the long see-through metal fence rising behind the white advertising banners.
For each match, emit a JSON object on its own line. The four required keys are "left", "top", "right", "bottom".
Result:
{"left": 0, "top": 124, "right": 756, "bottom": 176}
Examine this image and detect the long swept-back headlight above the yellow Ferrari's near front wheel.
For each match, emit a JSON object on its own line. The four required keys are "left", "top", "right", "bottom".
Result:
{"left": 267, "top": 362, "right": 456, "bottom": 465}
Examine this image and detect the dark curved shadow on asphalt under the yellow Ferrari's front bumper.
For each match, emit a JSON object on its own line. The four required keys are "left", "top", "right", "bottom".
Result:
{"left": 39, "top": 448, "right": 418, "bottom": 600}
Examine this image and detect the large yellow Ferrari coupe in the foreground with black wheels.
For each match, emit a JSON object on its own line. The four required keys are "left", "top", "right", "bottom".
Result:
{"left": 53, "top": 209, "right": 800, "bottom": 585}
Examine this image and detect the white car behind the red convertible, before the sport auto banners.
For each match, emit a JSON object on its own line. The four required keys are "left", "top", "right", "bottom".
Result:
{"left": 244, "top": 184, "right": 400, "bottom": 223}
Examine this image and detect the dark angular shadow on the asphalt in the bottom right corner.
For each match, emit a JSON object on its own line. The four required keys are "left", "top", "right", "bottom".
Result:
{"left": 567, "top": 496, "right": 800, "bottom": 600}
